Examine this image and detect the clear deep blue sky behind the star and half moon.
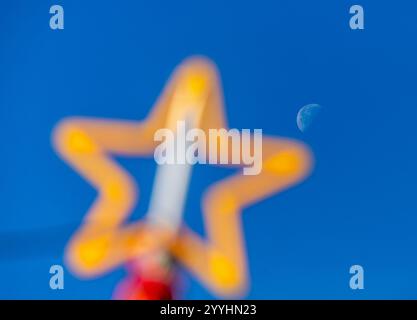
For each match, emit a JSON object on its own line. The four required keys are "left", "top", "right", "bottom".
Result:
{"left": 0, "top": 0, "right": 417, "bottom": 299}
